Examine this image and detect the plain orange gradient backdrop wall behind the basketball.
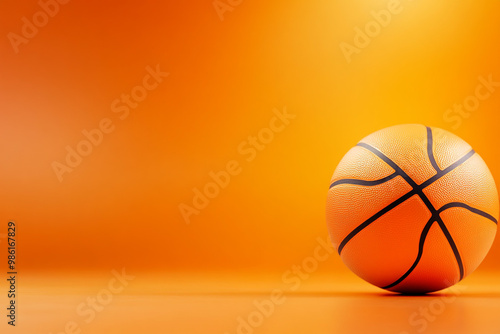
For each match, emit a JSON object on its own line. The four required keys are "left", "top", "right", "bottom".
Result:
{"left": 0, "top": 0, "right": 500, "bottom": 332}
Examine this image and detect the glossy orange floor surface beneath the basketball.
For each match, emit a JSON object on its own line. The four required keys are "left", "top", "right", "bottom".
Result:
{"left": 0, "top": 273, "right": 500, "bottom": 334}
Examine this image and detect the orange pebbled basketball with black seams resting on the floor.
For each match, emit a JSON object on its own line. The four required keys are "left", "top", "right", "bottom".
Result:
{"left": 326, "top": 124, "right": 498, "bottom": 294}
